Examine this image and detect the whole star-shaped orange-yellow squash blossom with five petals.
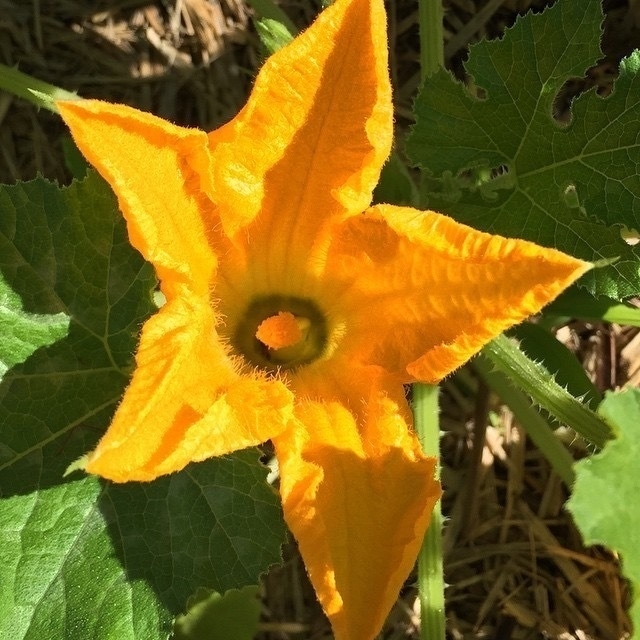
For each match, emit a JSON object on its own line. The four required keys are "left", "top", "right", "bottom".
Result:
{"left": 58, "top": 0, "right": 590, "bottom": 640}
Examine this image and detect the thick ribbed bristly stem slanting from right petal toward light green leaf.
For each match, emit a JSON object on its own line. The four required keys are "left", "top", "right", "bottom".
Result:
{"left": 482, "top": 335, "right": 612, "bottom": 447}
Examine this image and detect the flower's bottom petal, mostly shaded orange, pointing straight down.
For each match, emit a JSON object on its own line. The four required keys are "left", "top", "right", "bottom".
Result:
{"left": 274, "top": 393, "right": 440, "bottom": 640}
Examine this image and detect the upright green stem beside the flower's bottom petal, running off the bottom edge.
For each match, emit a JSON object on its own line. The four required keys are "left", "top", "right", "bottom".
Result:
{"left": 413, "top": 384, "right": 446, "bottom": 640}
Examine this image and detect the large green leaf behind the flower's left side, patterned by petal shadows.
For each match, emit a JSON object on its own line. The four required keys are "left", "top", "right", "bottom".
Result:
{"left": 0, "top": 173, "right": 284, "bottom": 640}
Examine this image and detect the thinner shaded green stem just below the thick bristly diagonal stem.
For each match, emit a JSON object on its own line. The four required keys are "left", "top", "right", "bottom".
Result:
{"left": 473, "top": 354, "right": 575, "bottom": 487}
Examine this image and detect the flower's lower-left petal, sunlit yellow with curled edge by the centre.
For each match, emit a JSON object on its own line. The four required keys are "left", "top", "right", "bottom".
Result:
{"left": 85, "top": 294, "right": 293, "bottom": 482}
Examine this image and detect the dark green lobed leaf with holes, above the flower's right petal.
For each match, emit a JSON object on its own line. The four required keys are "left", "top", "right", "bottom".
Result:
{"left": 407, "top": 0, "right": 640, "bottom": 299}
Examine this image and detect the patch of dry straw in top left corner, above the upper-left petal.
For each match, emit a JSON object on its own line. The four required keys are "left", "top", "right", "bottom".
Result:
{"left": 0, "top": 0, "right": 260, "bottom": 182}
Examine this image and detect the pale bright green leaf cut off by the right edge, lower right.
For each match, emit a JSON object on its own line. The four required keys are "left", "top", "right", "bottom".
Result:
{"left": 567, "top": 389, "right": 640, "bottom": 630}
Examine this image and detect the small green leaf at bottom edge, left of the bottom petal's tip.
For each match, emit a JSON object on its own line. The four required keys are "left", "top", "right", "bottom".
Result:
{"left": 173, "top": 586, "right": 260, "bottom": 640}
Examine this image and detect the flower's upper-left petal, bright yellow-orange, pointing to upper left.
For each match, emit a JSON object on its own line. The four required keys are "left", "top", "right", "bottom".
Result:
{"left": 57, "top": 100, "right": 216, "bottom": 298}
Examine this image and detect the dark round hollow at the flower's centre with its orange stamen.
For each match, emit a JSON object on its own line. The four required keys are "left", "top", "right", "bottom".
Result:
{"left": 231, "top": 295, "right": 328, "bottom": 371}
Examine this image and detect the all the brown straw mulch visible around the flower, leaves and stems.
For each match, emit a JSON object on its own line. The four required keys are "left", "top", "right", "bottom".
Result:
{"left": 0, "top": 0, "right": 640, "bottom": 640}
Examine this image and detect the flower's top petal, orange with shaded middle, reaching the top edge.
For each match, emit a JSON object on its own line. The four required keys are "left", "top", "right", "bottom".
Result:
{"left": 210, "top": 0, "right": 393, "bottom": 280}
